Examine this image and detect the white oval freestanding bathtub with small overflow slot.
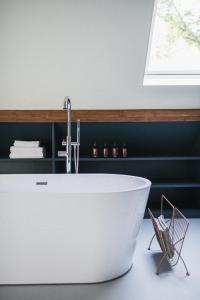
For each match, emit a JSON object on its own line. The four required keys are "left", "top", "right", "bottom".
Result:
{"left": 0, "top": 174, "right": 151, "bottom": 284}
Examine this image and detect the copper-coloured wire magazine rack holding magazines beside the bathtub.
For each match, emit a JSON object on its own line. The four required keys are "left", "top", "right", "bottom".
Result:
{"left": 148, "top": 195, "right": 190, "bottom": 276}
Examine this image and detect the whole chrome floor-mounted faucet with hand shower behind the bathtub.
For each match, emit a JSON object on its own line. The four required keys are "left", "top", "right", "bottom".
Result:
{"left": 62, "top": 96, "right": 80, "bottom": 174}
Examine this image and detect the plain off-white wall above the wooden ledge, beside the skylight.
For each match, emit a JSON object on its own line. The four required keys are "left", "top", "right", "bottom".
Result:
{"left": 0, "top": 0, "right": 200, "bottom": 109}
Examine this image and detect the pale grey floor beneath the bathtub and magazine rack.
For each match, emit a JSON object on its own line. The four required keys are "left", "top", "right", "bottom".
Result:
{"left": 0, "top": 219, "right": 200, "bottom": 300}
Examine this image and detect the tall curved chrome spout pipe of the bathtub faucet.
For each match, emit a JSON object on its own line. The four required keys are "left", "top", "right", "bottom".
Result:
{"left": 64, "top": 96, "right": 72, "bottom": 173}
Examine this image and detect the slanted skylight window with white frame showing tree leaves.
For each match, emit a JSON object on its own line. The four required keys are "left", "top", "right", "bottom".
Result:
{"left": 144, "top": 0, "right": 200, "bottom": 85}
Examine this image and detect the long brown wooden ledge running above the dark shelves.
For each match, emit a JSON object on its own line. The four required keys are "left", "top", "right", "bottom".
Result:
{"left": 0, "top": 109, "right": 200, "bottom": 123}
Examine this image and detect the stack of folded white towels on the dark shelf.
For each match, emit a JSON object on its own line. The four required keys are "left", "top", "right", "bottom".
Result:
{"left": 9, "top": 141, "right": 44, "bottom": 158}
